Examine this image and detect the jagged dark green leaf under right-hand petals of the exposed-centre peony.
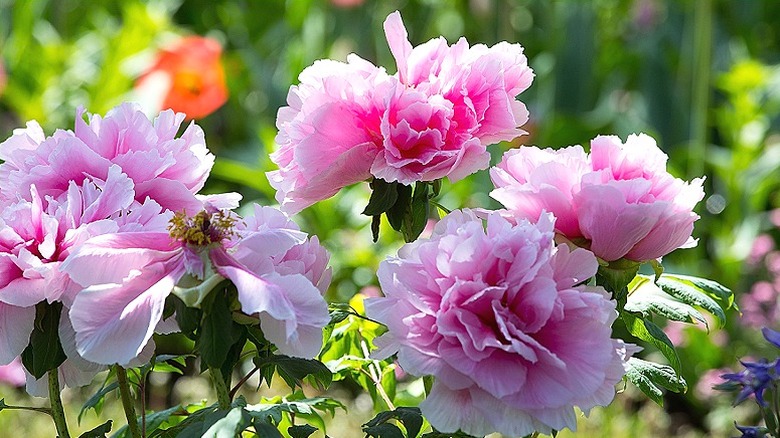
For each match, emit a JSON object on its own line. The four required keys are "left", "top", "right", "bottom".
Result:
{"left": 254, "top": 355, "right": 333, "bottom": 390}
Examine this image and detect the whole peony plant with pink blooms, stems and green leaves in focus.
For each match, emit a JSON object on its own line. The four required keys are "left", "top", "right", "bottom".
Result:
{"left": 0, "top": 12, "right": 736, "bottom": 438}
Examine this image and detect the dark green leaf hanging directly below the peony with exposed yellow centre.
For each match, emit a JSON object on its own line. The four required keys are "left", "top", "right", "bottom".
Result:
{"left": 195, "top": 291, "right": 242, "bottom": 368}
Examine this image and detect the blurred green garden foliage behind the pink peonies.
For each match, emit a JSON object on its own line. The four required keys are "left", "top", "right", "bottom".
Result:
{"left": 0, "top": 0, "right": 780, "bottom": 437}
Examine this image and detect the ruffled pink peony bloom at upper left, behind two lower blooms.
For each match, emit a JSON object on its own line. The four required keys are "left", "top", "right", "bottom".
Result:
{"left": 0, "top": 103, "right": 214, "bottom": 214}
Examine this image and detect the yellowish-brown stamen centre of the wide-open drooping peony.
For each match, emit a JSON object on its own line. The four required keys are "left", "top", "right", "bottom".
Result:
{"left": 168, "top": 211, "right": 236, "bottom": 246}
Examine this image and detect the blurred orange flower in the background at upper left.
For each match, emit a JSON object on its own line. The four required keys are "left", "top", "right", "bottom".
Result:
{"left": 135, "top": 36, "right": 228, "bottom": 119}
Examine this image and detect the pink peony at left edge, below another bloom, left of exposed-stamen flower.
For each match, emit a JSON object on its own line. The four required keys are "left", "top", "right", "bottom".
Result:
{"left": 0, "top": 166, "right": 165, "bottom": 364}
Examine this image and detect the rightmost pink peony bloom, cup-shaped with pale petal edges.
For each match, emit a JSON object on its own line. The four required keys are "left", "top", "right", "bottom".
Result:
{"left": 490, "top": 134, "right": 704, "bottom": 261}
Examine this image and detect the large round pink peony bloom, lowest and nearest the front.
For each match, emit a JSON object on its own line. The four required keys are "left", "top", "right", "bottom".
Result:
{"left": 366, "top": 210, "right": 631, "bottom": 436}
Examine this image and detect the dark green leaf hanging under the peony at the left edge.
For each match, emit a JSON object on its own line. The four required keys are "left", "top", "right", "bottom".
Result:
{"left": 22, "top": 301, "right": 67, "bottom": 379}
